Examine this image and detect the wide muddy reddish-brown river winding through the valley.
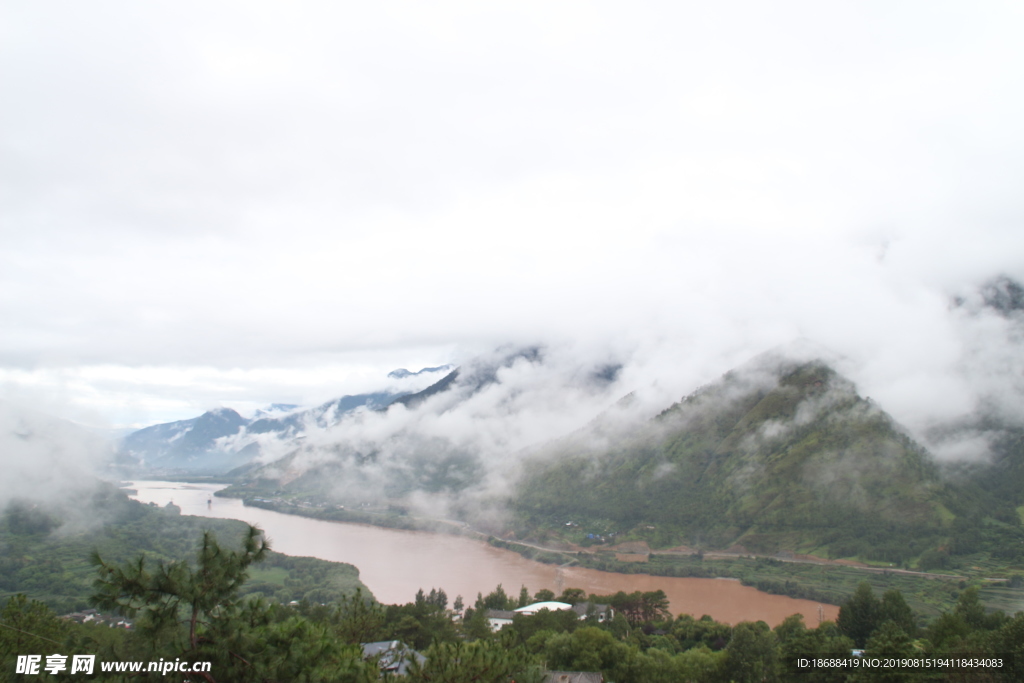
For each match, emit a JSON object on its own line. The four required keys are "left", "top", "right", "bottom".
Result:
{"left": 132, "top": 481, "right": 839, "bottom": 627}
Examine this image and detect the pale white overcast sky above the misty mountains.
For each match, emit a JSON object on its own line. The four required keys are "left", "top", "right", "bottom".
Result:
{"left": 0, "top": 0, "right": 1024, "bottom": 427}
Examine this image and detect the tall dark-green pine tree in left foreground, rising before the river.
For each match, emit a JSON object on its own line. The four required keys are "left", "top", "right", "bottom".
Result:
{"left": 92, "top": 526, "right": 376, "bottom": 683}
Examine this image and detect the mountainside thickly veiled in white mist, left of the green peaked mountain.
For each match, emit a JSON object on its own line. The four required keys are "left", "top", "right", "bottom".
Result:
{"left": 221, "top": 346, "right": 647, "bottom": 516}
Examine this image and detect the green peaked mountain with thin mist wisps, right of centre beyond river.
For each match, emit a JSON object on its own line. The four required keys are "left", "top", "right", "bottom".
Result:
{"left": 512, "top": 356, "right": 950, "bottom": 562}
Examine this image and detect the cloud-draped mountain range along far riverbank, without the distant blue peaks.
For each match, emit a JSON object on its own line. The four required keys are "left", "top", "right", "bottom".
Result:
{"left": 209, "top": 279, "right": 1024, "bottom": 562}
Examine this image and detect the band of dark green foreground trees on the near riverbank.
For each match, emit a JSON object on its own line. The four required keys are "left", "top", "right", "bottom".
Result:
{"left": 0, "top": 518, "right": 1024, "bottom": 683}
